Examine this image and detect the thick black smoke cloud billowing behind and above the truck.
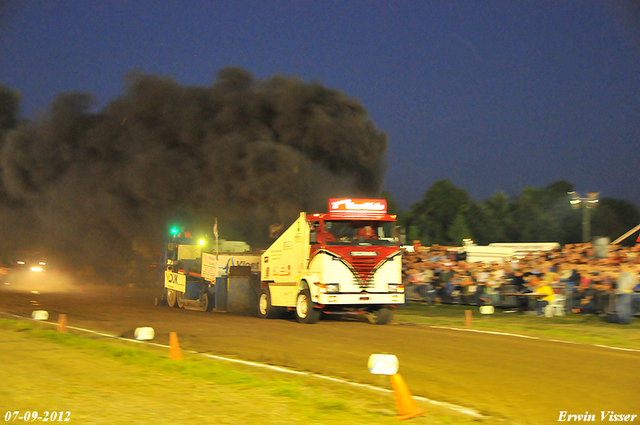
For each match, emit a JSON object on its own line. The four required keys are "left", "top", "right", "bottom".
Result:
{"left": 0, "top": 68, "right": 387, "bottom": 276}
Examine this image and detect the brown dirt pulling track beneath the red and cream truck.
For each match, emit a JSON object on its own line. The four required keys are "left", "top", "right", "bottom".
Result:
{"left": 0, "top": 278, "right": 640, "bottom": 424}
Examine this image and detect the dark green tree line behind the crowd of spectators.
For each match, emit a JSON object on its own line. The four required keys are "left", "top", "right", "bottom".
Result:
{"left": 384, "top": 180, "right": 640, "bottom": 246}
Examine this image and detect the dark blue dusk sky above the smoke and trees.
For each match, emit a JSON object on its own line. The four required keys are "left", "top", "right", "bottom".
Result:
{"left": 0, "top": 0, "right": 640, "bottom": 207}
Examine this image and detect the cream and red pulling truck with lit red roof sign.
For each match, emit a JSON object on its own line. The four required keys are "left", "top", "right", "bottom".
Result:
{"left": 258, "top": 199, "right": 404, "bottom": 324}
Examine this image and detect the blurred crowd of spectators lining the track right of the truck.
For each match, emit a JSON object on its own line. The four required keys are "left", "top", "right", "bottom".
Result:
{"left": 403, "top": 243, "right": 640, "bottom": 322}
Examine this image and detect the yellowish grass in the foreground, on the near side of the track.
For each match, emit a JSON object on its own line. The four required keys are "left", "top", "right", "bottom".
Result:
{"left": 0, "top": 319, "right": 495, "bottom": 425}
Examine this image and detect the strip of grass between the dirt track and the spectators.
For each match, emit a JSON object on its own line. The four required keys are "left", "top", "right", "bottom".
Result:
{"left": 395, "top": 302, "right": 640, "bottom": 349}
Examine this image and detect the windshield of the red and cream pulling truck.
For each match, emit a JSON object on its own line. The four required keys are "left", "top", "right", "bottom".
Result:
{"left": 324, "top": 220, "right": 398, "bottom": 246}
